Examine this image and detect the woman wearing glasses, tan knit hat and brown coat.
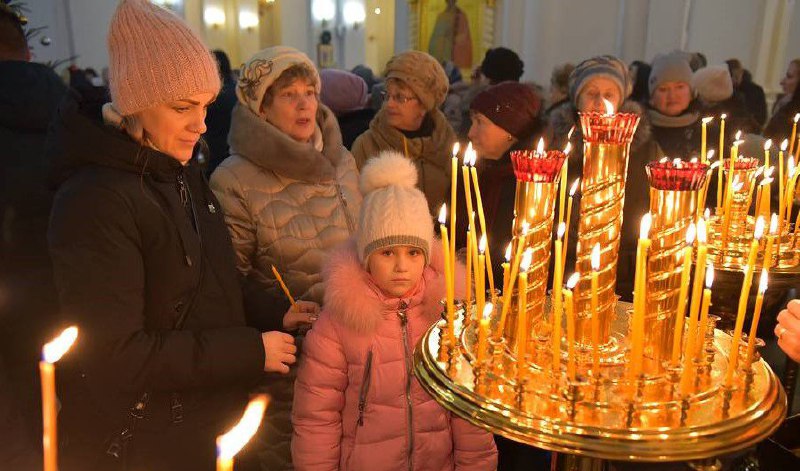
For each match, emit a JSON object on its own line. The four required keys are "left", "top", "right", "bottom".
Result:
{"left": 353, "top": 51, "right": 456, "bottom": 213}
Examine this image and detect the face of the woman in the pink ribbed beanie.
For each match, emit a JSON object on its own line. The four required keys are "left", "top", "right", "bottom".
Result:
{"left": 136, "top": 92, "right": 215, "bottom": 164}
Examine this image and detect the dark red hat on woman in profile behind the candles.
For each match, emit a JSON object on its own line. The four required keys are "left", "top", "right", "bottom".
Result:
{"left": 469, "top": 82, "right": 542, "bottom": 139}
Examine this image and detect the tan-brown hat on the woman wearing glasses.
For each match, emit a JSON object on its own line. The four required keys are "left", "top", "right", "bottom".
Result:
{"left": 384, "top": 51, "right": 450, "bottom": 111}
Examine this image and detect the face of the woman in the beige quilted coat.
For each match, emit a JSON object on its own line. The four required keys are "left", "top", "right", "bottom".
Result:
{"left": 261, "top": 78, "right": 319, "bottom": 142}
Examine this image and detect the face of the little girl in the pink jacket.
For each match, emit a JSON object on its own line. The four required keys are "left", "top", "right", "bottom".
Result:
{"left": 367, "top": 245, "right": 425, "bottom": 298}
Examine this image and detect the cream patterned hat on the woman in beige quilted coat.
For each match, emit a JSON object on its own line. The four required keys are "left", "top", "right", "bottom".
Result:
{"left": 236, "top": 46, "right": 321, "bottom": 116}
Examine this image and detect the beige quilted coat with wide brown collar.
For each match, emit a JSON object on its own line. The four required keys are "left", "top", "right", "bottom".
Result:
{"left": 211, "top": 104, "right": 361, "bottom": 303}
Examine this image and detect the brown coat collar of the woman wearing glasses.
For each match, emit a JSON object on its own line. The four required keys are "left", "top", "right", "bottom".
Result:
{"left": 369, "top": 108, "right": 456, "bottom": 169}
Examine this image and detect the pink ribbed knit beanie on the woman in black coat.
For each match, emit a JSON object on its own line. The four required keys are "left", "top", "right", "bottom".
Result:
{"left": 108, "top": 0, "right": 220, "bottom": 116}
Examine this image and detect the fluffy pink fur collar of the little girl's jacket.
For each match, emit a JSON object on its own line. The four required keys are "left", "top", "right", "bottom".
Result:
{"left": 322, "top": 239, "right": 465, "bottom": 334}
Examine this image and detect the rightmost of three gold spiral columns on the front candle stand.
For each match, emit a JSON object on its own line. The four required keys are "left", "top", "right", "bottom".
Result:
{"left": 644, "top": 188, "right": 700, "bottom": 371}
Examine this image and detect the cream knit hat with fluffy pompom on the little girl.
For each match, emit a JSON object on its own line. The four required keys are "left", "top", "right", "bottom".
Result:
{"left": 356, "top": 151, "right": 433, "bottom": 265}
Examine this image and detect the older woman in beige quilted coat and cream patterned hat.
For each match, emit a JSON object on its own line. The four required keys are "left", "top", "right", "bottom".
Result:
{"left": 211, "top": 46, "right": 361, "bottom": 469}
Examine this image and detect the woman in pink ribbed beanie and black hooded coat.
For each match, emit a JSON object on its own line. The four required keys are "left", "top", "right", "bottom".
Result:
{"left": 48, "top": 0, "right": 300, "bottom": 471}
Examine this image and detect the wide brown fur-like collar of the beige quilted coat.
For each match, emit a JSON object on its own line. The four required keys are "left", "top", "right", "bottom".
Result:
{"left": 228, "top": 103, "right": 346, "bottom": 183}
